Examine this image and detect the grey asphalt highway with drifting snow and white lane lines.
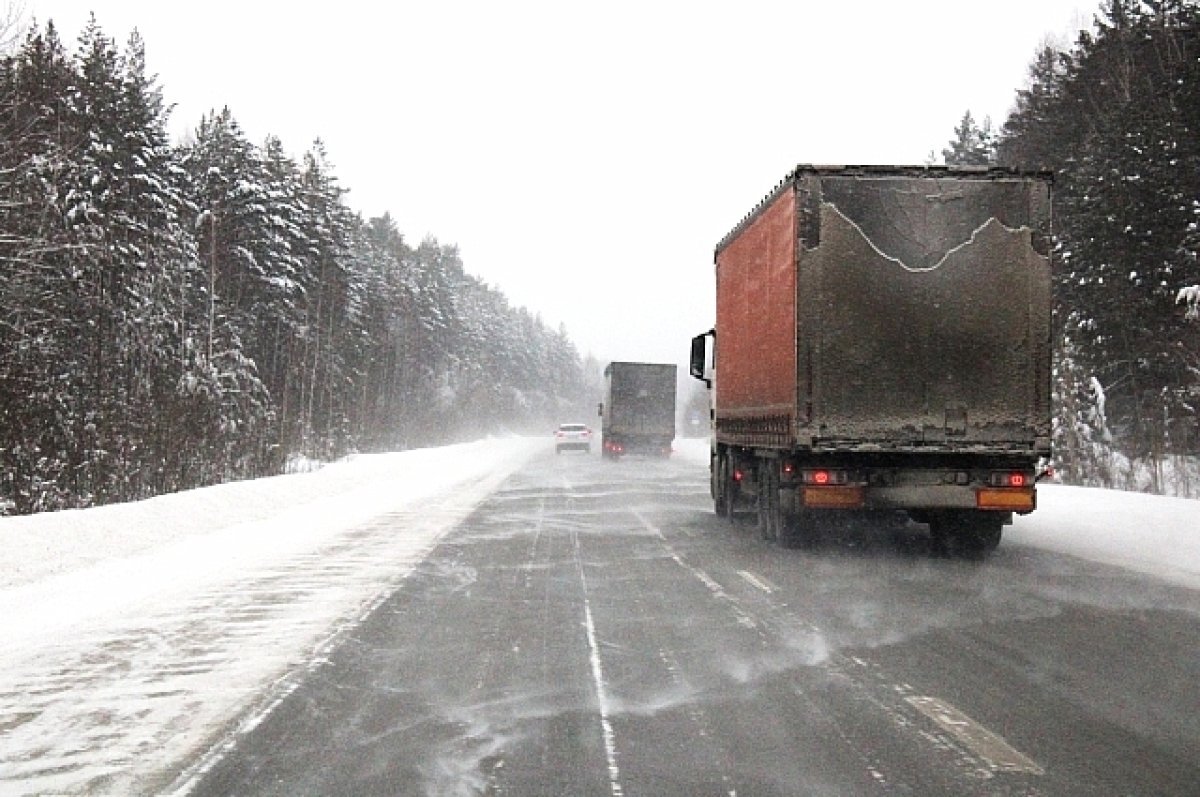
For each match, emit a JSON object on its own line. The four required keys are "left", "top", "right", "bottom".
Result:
{"left": 184, "top": 453, "right": 1200, "bottom": 797}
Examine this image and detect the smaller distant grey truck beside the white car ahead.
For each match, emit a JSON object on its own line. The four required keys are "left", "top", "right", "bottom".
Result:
{"left": 599, "top": 362, "right": 676, "bottom": 459}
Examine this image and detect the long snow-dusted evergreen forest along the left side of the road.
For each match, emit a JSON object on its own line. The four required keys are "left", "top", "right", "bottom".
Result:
{"left": 0, "top": 18, "right": 595, "bottom": 514}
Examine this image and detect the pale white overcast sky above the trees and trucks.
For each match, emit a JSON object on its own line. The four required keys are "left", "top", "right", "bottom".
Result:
{"left": 23, "top": 0, "right": 1099, "bottom": 362}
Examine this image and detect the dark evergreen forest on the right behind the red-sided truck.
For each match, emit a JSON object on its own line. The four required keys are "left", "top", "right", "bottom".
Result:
{"left": 942, "top": 0, "right": 1200, "bottom": 496}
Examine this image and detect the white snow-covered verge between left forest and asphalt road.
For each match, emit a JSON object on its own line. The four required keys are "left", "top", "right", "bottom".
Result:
{"left": 0, "top": 438, "right": 548, "bottom": 795}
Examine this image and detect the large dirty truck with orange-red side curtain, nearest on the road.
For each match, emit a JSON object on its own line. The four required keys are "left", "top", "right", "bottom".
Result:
{"left": 690, "top": 166, "right": 1052, "bottom": 557}
